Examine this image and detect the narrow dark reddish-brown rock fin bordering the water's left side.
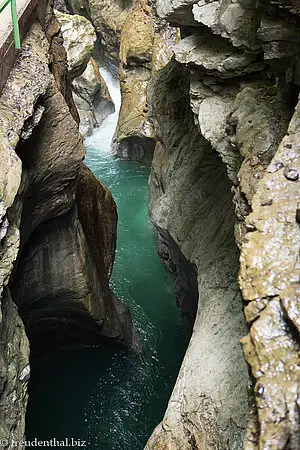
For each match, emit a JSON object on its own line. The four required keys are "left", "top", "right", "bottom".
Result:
{"left": 76, "top": 164, "right": 132, "bottom": 345}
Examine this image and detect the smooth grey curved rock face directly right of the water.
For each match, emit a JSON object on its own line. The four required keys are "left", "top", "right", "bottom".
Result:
{"left": 146, "top": 61, "right": 248, "bottom": 450}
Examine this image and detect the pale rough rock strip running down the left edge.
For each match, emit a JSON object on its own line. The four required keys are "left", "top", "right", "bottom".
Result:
{"left": 0, "top": 25, "right": 50, "bottom": 448}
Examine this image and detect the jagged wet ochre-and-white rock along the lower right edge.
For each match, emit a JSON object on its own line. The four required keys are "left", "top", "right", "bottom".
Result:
{"left": 239, "top": 104, "right": 300, "bottom": 449}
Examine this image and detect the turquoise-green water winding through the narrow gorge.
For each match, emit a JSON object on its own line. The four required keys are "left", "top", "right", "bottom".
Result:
{"left": 27, "top": 125, "right": 188, "bottom": 450}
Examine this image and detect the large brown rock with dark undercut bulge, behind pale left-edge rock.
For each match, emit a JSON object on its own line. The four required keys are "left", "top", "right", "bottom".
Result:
{"left": 11, "top": 78, "right": 129, "bottom": 354}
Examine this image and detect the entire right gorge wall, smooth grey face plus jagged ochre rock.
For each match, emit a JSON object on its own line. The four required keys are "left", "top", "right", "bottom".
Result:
{"left": 146, "top": 0, "right": 300, "bottom": 450}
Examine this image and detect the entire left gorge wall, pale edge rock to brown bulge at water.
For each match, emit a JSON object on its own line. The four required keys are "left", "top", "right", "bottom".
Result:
{"left": 0, "top": 2, "right": 131, "bottom": 449}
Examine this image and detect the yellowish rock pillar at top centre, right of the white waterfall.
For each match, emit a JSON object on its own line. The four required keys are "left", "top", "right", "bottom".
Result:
{"left": 61, "top": 0, "right": 178, "bottom": 162}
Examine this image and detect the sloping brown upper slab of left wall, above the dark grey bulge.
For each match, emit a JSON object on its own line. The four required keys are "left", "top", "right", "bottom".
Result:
{"left": 18, "top": 84, "right": 85, "bottom": 243}
